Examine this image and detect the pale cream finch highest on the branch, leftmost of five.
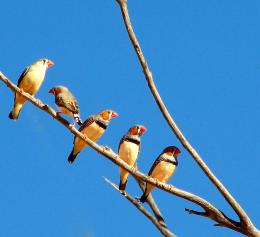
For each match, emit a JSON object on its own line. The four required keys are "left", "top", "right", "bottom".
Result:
{"left": 9, "top": 58, "right": 54, "bottom": 120}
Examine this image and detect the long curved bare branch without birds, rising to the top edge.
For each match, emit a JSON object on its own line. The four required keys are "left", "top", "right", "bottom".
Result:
{"left": 114, "top": 1, "right": 260, "bottom": 235}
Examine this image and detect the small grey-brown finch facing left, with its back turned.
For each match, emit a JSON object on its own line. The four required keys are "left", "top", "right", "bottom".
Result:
{"left": 49, "top": 86, "right": 83, "bottom": 126}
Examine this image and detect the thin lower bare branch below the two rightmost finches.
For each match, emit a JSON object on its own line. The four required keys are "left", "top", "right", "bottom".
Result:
{"left": 103, "top": 177, "right": 176, "bottom": 237}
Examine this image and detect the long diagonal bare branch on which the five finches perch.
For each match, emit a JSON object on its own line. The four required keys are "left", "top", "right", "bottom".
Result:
{"left": 0, "top": 72, "right": 259, "bottom": 237}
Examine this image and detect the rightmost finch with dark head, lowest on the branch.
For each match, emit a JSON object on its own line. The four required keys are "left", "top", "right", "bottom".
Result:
{"left": 139, "top": 146, "right": 181, "bottom": 203}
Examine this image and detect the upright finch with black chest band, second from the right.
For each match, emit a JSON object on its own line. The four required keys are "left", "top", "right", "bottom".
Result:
{"left": 118, "top": 125, "right": 147, "bottom": 194}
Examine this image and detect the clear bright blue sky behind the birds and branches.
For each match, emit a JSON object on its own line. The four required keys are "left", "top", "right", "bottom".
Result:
{"left": 0, "top": 0, "right": 260, "bottom": 237}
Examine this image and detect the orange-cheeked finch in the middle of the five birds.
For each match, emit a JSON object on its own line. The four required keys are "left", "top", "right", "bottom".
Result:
{"left": 68, "top": 109, "right": 119, "bottom": 164}
